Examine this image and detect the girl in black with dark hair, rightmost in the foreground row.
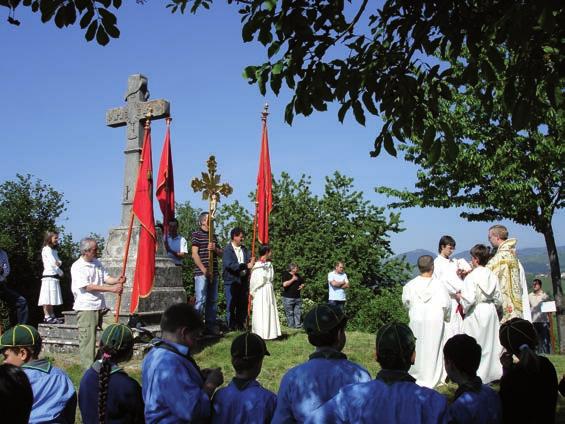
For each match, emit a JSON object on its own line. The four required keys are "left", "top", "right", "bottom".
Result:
{"left": 499, "top": 318, "right": 557, "bottom": 423}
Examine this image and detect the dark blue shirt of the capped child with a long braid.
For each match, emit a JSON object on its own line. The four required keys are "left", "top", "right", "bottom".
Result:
{"left": 78, "top": 361, "right": 145, "bottom": 424}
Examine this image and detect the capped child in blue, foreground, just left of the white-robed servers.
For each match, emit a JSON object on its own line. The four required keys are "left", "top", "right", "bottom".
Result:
{"left": 306, "top": 323, "right": 447, "bottom": 424}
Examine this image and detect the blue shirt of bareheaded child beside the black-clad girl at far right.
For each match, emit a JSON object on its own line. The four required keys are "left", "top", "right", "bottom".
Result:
{"left": 449, "top": 384, "right": 502, "bottom": 424}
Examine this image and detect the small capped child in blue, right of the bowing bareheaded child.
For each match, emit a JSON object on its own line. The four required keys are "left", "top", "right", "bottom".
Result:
{"left": 212, "top": 333, "right": 277, "bottom": 424}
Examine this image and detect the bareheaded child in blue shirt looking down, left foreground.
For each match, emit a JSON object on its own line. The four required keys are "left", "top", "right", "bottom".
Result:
{"left": 141, "top": 303, "right": 224, "bottom": 424}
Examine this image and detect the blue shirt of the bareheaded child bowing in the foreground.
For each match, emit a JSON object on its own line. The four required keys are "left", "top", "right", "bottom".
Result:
{"left": 141, "top": 339, "right": 210, "bottom": 424}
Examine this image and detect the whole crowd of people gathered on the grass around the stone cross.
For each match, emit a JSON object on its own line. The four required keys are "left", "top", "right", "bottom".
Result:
{"left": 0, "top": 220, "right": 565, "bottom": 423}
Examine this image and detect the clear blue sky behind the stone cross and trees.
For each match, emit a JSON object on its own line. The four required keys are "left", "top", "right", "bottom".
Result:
{"left": 0, "top": 1, "right": 565, "bottom": 253}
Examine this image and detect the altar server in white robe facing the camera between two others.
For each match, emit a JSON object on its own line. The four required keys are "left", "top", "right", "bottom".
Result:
{"left": 434, "top": 236, "right": 471, "bottom": 344}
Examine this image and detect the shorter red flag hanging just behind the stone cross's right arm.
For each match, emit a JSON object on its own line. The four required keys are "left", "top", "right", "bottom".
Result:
{"left": 156, "top": 118, "right": 175, "bottom": 234}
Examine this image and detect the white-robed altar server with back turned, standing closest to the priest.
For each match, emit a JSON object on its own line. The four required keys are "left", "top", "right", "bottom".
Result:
{"left": 460, "top": 244, "right": 502, "bottom": 384}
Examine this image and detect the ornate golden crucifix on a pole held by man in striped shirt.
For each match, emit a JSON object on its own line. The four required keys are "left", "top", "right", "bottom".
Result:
{"left": 190, "top": 156, "right": 233, "bottom": 277}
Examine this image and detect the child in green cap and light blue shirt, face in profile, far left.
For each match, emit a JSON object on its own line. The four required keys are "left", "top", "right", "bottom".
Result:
{"left": 0, "top": 324, "right": 77, "bottom": 424}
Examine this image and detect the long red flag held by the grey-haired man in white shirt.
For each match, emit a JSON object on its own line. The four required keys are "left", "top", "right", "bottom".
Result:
{"left": 130, "top": 123, "right": 156, "bottom": 313}
